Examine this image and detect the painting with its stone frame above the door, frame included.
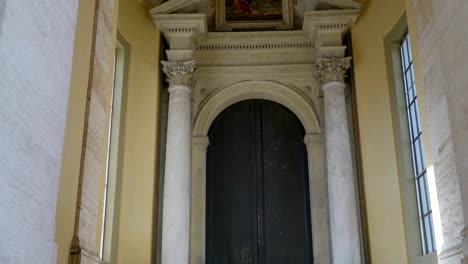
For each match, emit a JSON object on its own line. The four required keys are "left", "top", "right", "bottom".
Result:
{"left": 216, "top": 0, "right": 293, "bottom": 31}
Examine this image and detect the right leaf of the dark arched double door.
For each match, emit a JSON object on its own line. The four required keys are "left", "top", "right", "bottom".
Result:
{"left": 262, "top": 103, "right": 311, "bottom": 264}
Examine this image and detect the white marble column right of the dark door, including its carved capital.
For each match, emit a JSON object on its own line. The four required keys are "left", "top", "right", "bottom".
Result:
{"left": 316, "top": 57, "right": 361, "bottom": 264}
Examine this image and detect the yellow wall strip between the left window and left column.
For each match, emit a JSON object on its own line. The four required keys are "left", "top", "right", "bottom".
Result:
{"left": 117, "top": 0, "right": 160, "bottom": 264}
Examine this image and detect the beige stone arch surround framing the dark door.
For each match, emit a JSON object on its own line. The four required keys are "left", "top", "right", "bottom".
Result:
{"left": 190, "top": 81, "right": 330, "bottom": 264}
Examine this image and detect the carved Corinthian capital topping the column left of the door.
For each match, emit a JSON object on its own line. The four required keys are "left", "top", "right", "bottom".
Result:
{"left": 161, "top": 60, "right": 197, "bottom": 88}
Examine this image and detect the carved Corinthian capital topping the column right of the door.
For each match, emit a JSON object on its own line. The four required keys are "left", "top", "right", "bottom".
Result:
{"left": 315, "top": 57, "right": 351, "bottom": 84}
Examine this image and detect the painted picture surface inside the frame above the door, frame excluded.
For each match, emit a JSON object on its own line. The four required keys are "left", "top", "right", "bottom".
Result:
{"left": 225, "top": 0, "right": 283, "bottom": 21}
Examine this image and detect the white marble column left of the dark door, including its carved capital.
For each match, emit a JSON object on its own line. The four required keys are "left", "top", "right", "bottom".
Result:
{"left": 161, "top": 61, "right": 196, "bottom": 264}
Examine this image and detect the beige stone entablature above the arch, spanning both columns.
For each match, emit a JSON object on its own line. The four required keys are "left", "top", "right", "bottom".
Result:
{"left": 151, "top": 9, "right": 359, "bottom": 131}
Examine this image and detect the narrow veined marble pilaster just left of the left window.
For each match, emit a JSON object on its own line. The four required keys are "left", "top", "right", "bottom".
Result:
{"left": 69, "top": 0, "right": 118, "bottom": 264}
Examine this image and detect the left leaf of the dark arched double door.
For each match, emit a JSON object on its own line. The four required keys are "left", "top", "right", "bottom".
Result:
{"left": 207, "top": 104, "right": 257, "bottom": 264}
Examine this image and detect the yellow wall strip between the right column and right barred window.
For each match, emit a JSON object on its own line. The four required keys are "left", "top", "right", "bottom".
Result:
{"left": 351, "top": 0, "right": 408, "bottom": 264}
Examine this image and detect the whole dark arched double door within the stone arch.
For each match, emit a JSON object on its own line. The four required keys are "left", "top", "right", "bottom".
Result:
{"left": 206, "top": 100, "right": 313, "bottom": 264}
